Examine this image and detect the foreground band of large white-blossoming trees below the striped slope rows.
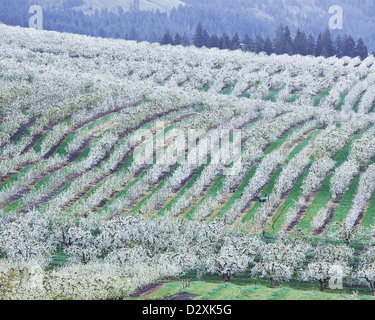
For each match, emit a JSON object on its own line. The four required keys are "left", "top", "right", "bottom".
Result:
{"left": 0, "top": 211, "right": 375, "bottom": 299}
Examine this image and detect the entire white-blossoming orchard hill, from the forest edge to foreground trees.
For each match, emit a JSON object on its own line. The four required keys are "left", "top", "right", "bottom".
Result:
{"left": 0, "top": 25, "right": 375, "bottom": 299}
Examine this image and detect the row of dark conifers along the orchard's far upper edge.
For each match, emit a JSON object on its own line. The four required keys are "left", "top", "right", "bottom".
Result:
{"left": 160, "top": 23, "right": 368, "bottom": 60}
